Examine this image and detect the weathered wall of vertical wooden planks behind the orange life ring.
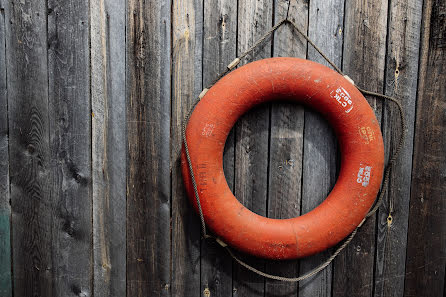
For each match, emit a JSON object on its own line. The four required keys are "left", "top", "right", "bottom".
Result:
{"left": 0, "top": 0, "right": 446, "bottom": 297}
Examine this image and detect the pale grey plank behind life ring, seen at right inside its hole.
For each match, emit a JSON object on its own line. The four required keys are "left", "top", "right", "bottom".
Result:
{"left": 299, "top": 0, "right": 344, "bottom": 296}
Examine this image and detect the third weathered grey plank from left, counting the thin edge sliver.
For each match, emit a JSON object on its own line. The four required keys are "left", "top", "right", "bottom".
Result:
{"left": 46, "top": 0, "right": 92, "bottom": 296}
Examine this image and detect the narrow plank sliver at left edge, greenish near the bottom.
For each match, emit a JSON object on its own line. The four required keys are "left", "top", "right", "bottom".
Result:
{"left": 0, "top": 0, "right": 12, "bottom": 297}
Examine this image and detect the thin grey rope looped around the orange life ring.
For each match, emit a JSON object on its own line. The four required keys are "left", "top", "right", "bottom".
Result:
{"left": 182, "top": 15, "right": 406, "bottom": 282}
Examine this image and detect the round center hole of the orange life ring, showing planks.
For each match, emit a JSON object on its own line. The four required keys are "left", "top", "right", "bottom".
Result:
{"left": 223, "top": 102, "right": 340, "bottom": 219}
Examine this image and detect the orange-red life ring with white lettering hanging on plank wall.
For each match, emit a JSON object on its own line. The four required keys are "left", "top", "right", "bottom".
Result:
{"left": 182, "top": 58, "right": 384, "bottom": 259}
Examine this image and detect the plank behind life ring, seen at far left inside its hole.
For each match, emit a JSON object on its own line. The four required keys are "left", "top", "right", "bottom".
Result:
{"left": 201, "top": 0, "right": 237, "bottom": 297}
